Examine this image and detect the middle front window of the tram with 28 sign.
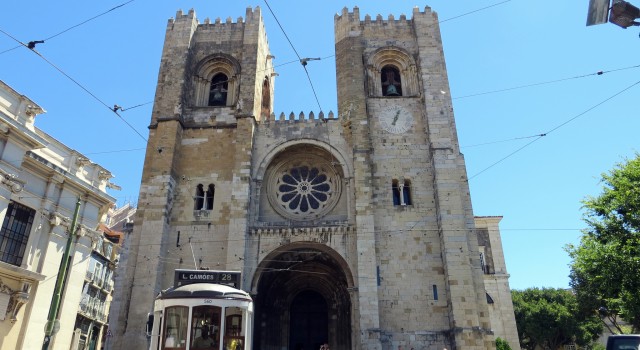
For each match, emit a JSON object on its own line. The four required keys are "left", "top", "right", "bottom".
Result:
{"left": 191, "top": 306, "right": 221, "bottom": 349}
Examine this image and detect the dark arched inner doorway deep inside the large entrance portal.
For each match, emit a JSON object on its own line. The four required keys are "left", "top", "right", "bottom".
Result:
{"left": 289, "top": 290, "right": 329, "bottom": 350}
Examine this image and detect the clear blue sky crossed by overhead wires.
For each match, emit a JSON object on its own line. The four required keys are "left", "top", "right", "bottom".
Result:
{"left": 0, "top": 0, "right": 640, "bottom": 289}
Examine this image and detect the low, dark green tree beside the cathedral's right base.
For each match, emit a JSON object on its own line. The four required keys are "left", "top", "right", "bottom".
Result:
{"left": 511, "top": 288, "right": 602, "bottom": 350}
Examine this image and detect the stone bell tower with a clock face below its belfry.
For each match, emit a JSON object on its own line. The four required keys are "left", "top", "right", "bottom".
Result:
{"left": 335, "top": 7, "right": 494, "bottom": 350}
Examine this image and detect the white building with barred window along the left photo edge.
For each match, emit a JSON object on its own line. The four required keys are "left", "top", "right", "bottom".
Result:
{"left": 0, "top": 81, "right": 114, "bottom": 350}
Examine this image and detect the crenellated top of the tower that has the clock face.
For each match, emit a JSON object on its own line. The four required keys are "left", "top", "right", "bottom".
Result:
{"left": 334, "top": 6, "right": 438, "bottom": 42}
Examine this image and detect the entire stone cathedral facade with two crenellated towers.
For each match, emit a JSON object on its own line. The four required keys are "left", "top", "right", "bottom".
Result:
{"left": 110, "top": 7, "right": 518, "bottom": 350}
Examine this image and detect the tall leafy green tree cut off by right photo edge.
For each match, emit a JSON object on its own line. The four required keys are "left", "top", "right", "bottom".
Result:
{"left": 567, "top": 154, "right": 640, "bottom": 333}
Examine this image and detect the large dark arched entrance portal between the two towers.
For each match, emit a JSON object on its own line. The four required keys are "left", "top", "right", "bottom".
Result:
{"left": 254, "top": 244, "right": 351, "bottom": 350}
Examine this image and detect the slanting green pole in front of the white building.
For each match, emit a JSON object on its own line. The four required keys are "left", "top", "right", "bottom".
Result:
{"left": 42, "top": 197, "right": 81, "bottom": 350}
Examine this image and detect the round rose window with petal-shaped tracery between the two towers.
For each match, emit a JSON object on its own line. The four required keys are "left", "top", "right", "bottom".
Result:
{"left": 276, "top": 165, "right": 333, "bottom": 215}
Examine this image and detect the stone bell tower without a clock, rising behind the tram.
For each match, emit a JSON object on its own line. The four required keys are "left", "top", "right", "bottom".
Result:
{"left": 111, "top": 8, "right": 274, "bottom": 349}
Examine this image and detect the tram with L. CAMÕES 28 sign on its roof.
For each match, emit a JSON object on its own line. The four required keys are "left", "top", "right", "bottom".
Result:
{"left": 147, "top": 270, "right": 253, "bottom": 350}
